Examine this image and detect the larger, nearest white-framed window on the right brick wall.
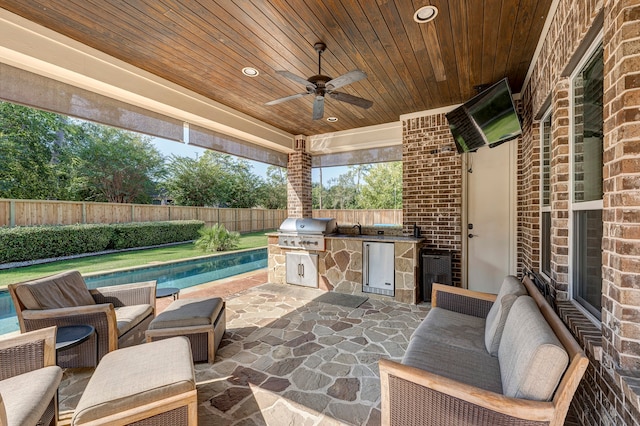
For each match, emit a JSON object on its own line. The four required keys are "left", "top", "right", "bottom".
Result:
{"left": 569, "top": 40, "right": 604, "bottom": 319}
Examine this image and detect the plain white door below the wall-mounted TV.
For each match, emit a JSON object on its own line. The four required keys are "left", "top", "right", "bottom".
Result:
{"left": 463, "top": 141, "right": 517, "bottom": 293}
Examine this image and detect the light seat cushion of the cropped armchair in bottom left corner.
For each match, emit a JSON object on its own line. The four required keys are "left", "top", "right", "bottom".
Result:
{"left": 0, "top": 366, "right": 62, "bottom": 426}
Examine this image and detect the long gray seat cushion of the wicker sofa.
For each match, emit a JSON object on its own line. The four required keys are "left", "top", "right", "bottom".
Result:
{"left": 402, "top": 338, "right": 502, "bottom": 393}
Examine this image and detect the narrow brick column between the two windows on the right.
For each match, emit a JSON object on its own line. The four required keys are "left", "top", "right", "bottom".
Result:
{"left": 550, "top": 79, "right": 571, "bottom": 300}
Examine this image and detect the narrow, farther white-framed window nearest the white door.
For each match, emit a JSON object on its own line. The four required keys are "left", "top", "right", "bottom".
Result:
{"left": 540, "top": 109, "right": 552, "bottom": 278}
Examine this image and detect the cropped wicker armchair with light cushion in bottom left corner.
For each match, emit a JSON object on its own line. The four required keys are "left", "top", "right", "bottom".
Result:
{"left": 0, "top": 327, "right": 62, "bottom": 426}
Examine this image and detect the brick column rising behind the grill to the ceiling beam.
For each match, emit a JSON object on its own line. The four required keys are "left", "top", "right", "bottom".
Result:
{"left": 287, "top": 135, "right": 312, "bottom": 218}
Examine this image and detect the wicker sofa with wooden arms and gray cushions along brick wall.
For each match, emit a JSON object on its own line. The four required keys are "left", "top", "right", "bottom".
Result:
{"left": 379, "top": 276, "right": 588, "bottom": 426}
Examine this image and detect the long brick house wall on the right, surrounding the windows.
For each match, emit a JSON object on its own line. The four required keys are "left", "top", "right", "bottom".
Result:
{"left": 518, "top": 0, "right": 640, "bottom": 426}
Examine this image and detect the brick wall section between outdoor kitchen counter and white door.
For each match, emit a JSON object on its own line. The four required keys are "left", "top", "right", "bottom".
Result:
{"left": 402, "top": 114, "right": 462, "bottom": 286}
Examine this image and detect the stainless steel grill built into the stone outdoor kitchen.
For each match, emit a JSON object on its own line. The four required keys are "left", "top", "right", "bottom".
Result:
{"left": 278, "top": 217, "right": 338, "bottom": 251}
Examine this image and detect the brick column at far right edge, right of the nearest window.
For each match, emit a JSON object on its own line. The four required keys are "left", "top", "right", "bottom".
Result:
{"left": 602, "top": 0, "right": 640, "bottom": 377}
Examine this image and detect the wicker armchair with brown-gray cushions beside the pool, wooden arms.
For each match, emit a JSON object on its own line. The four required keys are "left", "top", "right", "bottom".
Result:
{"left": 9, "top": 271, "right": 156, "bottom": 368}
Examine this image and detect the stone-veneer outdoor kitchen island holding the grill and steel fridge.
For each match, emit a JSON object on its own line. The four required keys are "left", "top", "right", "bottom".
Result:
{"left": 267, "top": 227, "right": 424, "bottom": 304}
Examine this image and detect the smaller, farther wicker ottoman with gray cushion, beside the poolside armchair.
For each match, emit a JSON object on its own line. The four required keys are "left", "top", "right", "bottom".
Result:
{"left": 146, "top": 297, "right": 227, "bottom": 364}
